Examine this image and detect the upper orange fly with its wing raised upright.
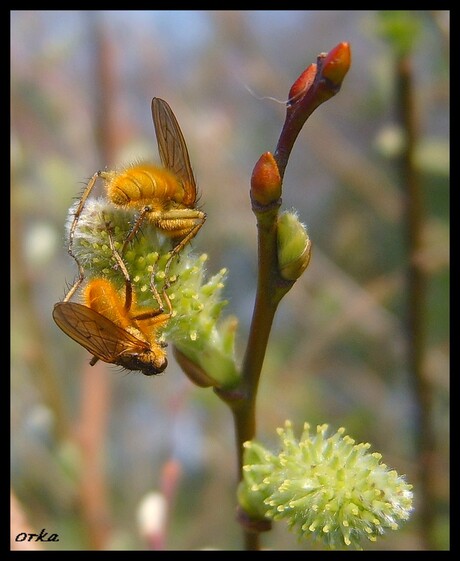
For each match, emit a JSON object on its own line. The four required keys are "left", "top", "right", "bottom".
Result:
{"left": 69, "top": 97, "right": 206, "bottom": 294}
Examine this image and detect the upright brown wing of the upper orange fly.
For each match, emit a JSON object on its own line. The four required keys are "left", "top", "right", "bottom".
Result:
{"left": 152, "top": 97, "right": 197, "bottom": 207}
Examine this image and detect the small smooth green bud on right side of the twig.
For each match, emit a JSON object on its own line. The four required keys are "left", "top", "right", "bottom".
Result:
{"left": 278, "top": 212, "right": 311, "bottom": 281}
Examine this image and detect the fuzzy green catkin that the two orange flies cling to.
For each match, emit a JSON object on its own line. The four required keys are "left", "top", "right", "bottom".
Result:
{"left": 68, "top": 198, "right": 239, "bottom": 387}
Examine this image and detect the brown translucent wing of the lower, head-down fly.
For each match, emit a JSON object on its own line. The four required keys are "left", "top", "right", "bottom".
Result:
{"left": 53, "top": 302, "right": 149, "bottom": 363}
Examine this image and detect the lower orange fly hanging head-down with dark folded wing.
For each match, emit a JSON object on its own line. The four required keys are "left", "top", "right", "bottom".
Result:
{"left": 53, "top": 220, "right": 172, "bottom": 376}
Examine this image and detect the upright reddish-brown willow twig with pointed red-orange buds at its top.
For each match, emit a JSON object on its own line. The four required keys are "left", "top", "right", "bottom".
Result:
{"left": 216, "top": 43, "right": 350, "bottom": 550}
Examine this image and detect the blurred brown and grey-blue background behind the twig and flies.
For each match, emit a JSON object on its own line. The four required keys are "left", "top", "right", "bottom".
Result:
{"left": 10, "top": 10, "right": 449, "bottom": 550}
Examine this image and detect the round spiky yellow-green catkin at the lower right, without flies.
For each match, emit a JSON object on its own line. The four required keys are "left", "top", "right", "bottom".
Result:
{"left": 238, "top": 421, "right": 412, "bottom": 549}
